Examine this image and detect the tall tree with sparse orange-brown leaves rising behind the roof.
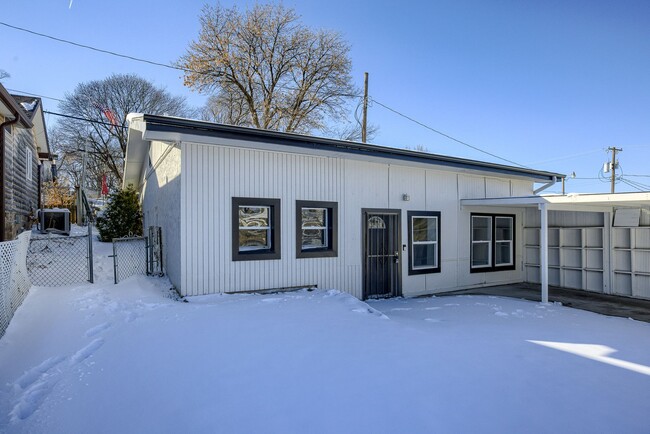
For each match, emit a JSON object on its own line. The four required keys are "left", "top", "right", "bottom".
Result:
{"left": 177, "top": 4, "right": 357, "bottom": 132}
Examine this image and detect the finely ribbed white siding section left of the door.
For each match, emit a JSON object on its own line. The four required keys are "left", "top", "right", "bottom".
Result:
{"left": 183, "top": 144, "right": 360, "bottom": 296}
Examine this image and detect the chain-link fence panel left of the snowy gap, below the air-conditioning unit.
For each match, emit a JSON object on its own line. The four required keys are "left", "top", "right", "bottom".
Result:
{"left": 27, "top": 234, "right": 93, "bottom": 286}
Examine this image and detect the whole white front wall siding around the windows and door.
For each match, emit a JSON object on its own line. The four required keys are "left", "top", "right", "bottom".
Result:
{"left": 172, "top": 143, "right": 532, "bottom": 297}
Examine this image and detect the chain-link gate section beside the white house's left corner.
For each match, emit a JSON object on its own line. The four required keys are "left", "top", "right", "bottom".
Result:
{"left": 112, "top": 226, "right": 163, "bottom": 283}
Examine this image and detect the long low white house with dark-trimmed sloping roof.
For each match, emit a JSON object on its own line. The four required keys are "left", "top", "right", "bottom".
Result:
{"left": 124, "top": 114, "right": 644, "bottom": 298}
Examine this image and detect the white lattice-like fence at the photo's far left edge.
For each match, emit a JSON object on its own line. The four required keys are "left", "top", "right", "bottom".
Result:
{"left": 0, "top": 232, "right": 32, "bottom": 337}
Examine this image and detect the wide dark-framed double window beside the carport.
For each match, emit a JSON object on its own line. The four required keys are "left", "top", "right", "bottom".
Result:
{"left": 470, "top": 214, "right": 515, "bottom": 272}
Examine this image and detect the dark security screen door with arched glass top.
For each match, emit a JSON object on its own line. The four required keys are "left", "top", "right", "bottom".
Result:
{"left": 362, "top": 209, "right": 401, "bottom": 299}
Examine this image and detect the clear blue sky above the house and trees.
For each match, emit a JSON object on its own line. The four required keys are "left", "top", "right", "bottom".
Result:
{"left": 0, "top": 0, "right": 650, "bottom": 192}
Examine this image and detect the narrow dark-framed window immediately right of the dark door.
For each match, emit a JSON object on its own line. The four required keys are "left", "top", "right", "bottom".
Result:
{"left": 407, "top": 211, "right": 441, "bottom": 275}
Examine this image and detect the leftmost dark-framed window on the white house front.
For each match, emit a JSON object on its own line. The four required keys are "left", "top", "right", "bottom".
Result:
{"left": 232, "top": 197, "right": 280, "bottom": 261}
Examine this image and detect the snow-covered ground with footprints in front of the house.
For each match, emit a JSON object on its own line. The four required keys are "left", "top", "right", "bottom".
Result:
{"left": 0, "top": 234, "right": 650, "bottom": 433}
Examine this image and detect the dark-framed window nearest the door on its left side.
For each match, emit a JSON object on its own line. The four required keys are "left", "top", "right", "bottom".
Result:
{"left": 296, "top": 200, "right": 338, "bottom": 258}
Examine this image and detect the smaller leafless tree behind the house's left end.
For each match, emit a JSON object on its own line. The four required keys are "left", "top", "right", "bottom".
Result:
{"left": 56, "top": 74, "right": 190, "bottom": 185}
